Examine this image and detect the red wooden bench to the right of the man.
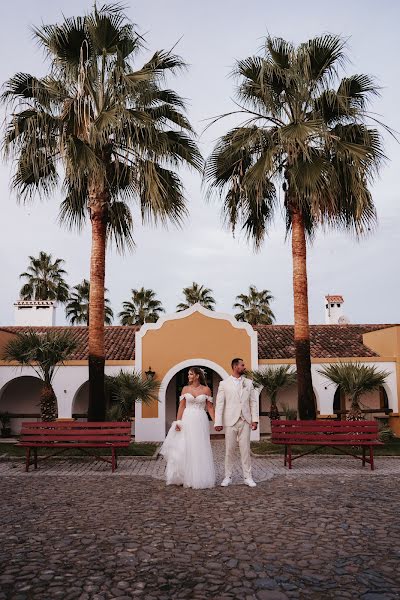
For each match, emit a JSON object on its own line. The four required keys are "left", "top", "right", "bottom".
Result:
{"left": 271, "top": 420, "right": 382, "bottom": 470}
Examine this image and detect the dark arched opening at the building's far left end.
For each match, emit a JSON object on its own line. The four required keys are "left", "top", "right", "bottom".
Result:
{"left": 0, "top": 375, "right": 42, "bottom": 434}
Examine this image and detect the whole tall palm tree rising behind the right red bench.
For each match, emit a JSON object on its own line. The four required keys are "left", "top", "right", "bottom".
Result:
{"left": 205, "top": 35, "right": 384, "bottom": 419}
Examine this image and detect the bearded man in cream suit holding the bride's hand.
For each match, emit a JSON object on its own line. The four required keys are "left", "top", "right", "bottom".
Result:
{"left": 215, "top": 358, "right": 258, "bottom": 487}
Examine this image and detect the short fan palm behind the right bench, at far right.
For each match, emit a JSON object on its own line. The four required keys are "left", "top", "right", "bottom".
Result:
{"left": 318, "top": 363, "right": 389, "bottom": 421}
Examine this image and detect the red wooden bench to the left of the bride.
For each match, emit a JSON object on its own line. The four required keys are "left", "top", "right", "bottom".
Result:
{"left": 18, "top": 421, "right": 131, "bottom": 472}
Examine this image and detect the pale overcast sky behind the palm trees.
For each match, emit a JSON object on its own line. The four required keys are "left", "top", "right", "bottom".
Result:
{"left": 0, "top": 0, "right": 400, "bottom": 325}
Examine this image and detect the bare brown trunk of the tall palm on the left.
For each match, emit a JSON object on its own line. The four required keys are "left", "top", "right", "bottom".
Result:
{"left": 88, "top": 192, "right": 107, "bottom": 421}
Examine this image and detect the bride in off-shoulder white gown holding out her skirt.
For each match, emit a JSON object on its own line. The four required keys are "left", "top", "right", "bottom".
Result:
{"left": 160, "top": 367, "right": 215, "bottom": 489}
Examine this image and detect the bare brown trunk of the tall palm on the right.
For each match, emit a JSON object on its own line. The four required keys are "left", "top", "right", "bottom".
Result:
{"left": 292, "top": 208, "right": 316, "bottom": 419}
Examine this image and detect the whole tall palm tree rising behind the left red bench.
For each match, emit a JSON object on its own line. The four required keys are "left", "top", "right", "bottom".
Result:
{"left": 3, "top": 4, "right": 202, "bottom": 420}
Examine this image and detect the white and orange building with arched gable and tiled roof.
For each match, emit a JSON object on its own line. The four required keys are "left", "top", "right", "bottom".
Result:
{"left": 0, "top": 305, "right": 400, "bottom": 441}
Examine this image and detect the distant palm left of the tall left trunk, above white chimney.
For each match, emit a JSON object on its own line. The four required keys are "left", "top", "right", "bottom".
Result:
{"left": 20, "top": 251, "right": 69, "bottom": 302}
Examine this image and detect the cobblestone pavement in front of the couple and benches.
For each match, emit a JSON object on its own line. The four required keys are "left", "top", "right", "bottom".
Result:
{"left": 0, "top": 442, "right": 400, "bottom": 600}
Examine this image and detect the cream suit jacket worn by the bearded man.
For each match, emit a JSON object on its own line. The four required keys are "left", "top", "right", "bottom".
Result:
{"left": 215, "top": 377, "right": 258, "bottom": 427}
